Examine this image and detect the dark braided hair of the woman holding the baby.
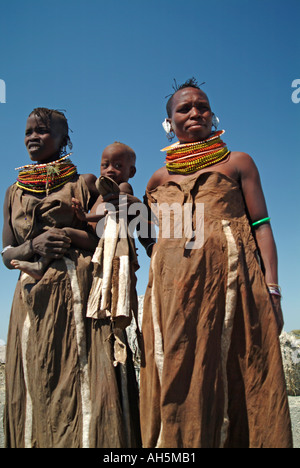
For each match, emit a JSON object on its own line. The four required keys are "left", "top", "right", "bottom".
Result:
{"left": 29, "top": 107, "right": 73, "bottom": 154}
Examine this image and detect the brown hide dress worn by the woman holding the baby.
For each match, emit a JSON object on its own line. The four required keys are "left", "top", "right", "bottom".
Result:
{"left": 5, "top": 176, "right": 140, "bottom": 448}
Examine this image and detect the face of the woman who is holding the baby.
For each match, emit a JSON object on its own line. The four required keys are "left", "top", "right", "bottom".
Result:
{"left": 24, "top": 115, "right": 63, "bottom": 163}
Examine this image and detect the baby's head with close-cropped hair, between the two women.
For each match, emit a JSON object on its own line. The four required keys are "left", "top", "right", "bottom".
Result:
{"left": 100, "top": 141, "right": 136, "bottom": 185}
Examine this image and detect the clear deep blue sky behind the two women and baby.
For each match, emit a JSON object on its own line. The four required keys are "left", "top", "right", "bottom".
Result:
{"left": 0, "top": 0, "right": 300, "bottom": 342}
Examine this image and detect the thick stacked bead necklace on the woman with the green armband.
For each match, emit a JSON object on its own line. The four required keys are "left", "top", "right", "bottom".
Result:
{"left": 161, "top": 130, "right": 230, "bottom": 174}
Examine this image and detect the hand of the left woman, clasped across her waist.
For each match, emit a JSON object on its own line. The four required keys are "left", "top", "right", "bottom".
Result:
{"left": 32, "top": 228, "right": 71, "bottom": 258}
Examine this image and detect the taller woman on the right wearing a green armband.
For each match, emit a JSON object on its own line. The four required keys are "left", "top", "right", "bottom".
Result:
{"left": 141, "top": 79, "right": 292, "bottom": 448}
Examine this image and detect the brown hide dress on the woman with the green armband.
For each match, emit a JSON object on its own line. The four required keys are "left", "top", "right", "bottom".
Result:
{"left": 141, "top": 172, "right": 292, "bottom": 448}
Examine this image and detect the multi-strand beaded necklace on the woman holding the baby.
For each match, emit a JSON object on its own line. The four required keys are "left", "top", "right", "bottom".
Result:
{"left": 16, "top": 153, "right": 77, "bottom": 195}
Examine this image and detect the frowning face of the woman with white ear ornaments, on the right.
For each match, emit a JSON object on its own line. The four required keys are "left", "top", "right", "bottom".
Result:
{"left": 168, "top": 88, "right": 213, "bottom": 143}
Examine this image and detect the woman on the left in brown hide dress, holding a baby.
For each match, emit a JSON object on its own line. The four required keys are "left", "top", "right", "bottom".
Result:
{"left": 2, "top": 108, "right": 139, "bottom": 448}
